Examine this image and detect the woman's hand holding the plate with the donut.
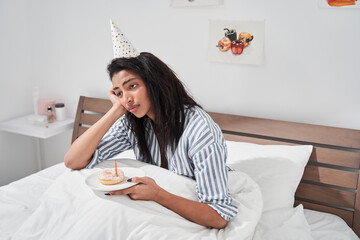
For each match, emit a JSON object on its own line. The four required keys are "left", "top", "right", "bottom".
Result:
{"left": 109, "top": 177, "right": 163, "bottom": 201}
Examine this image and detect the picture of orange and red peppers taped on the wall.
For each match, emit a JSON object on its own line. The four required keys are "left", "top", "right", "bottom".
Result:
{"left": 208, "top": 20, "right": 265, "bottom": 65}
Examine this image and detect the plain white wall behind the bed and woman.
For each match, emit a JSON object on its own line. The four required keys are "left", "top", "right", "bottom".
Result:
{"left": 0, "top": 0, "right": 360, "bottom": 185}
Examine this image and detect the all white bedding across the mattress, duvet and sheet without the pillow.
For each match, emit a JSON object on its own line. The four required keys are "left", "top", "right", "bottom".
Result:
{"left": 0, "top": 160, "right": 359, "bottom": 240}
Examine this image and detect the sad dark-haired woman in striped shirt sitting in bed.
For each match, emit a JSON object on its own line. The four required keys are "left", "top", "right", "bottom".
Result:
{"left": 65, "top": 53, "right": 238, "bottom": 229}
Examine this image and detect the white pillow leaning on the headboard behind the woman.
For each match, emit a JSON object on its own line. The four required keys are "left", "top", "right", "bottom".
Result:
{"left": 226, "top": 141, "right": 313, "bottom": 211}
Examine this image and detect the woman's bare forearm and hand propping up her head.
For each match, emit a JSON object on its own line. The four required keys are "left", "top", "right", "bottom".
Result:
{"left": 64, "top": 90, "right": 126, "bottom": 170}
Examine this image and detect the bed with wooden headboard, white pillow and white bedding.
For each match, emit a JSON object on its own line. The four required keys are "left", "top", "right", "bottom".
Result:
{"left": 0, "top": 96, "right": 360, "bottom": 240}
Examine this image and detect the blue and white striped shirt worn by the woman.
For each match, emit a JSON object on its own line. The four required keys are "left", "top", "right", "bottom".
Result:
{"left": 87, "top": 107, "right": 238, "bottom": 221}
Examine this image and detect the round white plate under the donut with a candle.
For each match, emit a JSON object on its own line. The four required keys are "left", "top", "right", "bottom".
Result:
{"left": 85, "top": 167, "right": 145, "bottom": 192}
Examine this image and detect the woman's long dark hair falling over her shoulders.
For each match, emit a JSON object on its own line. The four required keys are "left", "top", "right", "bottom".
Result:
{"left": 107, "top": 52, "right": 200, "bottom": 165}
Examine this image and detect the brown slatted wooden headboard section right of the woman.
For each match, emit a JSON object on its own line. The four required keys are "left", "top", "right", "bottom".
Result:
{"left": 209, "top": 112, "right": 360, "bottom": 237}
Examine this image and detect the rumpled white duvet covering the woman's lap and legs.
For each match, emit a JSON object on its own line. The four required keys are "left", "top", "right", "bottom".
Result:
{"left": 11, "top": 160, "right": 262, "bottom": 240}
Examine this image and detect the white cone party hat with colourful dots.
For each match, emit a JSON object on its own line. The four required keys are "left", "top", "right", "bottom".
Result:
{"left": 110, "top": 20, "right": 139, "bottom": 58}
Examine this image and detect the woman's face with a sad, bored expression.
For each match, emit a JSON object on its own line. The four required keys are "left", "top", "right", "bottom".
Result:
{"left": 112, "top": 70, "right": 155, "bottom": 121}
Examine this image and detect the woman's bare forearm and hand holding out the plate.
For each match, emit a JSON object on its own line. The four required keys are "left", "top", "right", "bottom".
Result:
{"left": 110, "top": 177, "right": 228, "bottom": 229}
